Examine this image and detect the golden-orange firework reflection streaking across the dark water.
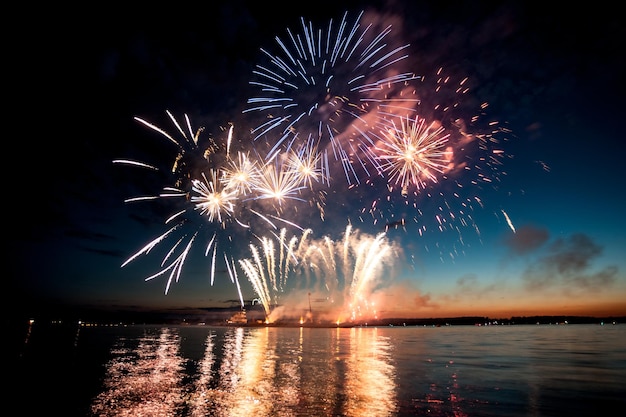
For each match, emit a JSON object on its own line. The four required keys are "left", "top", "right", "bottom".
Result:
{"left": 91, "top": 327, "right": 396, "bottom": 416}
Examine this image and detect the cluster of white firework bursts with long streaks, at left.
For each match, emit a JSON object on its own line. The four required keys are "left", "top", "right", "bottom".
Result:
{"left": 114, "top": 111, "right": 319, "bottom": 296}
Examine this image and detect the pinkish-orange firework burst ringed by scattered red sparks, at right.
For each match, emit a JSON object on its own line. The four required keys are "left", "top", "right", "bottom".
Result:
{"left": 360, "top": 69, "right": 510, "bottom": 260}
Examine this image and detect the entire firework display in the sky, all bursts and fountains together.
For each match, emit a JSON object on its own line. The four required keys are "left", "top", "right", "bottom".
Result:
{"left": 114, "top": 9, "right": 514, "bottom": 321}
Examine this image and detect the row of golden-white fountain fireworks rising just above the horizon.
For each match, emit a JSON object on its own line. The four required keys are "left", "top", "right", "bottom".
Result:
{"left": 239, "top": 225, "right": 398, "bottom": 322}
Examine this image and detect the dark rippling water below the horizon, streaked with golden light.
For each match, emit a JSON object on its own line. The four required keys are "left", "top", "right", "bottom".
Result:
{"left": 5, "top": 324, "right": 626, "bottom": 417}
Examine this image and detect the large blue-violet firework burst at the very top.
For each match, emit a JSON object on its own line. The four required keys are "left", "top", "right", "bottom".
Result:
{"left": 244, "top": 12, "right": 419, "bottom": 184}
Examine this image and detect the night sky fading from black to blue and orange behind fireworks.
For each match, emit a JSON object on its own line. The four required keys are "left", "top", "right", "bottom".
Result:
{"left": 11, "top": 0, "right": 626, "bottom": 317}
